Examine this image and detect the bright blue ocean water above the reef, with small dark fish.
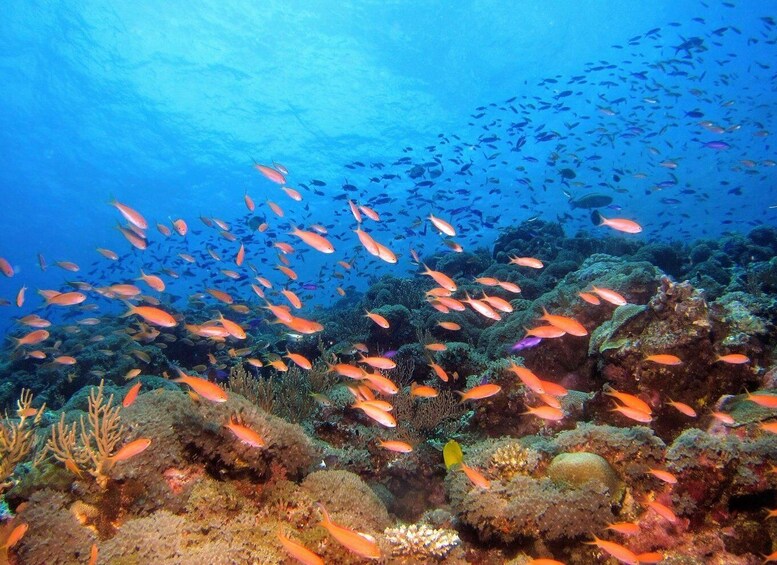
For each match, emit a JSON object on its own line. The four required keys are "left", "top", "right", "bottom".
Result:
{"left": 0, "top": 0, "right": 777, "bottom": 562}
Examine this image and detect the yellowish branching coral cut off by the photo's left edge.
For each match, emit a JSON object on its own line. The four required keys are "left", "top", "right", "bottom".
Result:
{"left": 0, "top": 389, "right": 46, "bottom": 492}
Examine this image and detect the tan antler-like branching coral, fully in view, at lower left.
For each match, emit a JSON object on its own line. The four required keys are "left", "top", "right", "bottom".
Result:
{"left": 46, "top": 381, "right": 124, "bottom": 488}
